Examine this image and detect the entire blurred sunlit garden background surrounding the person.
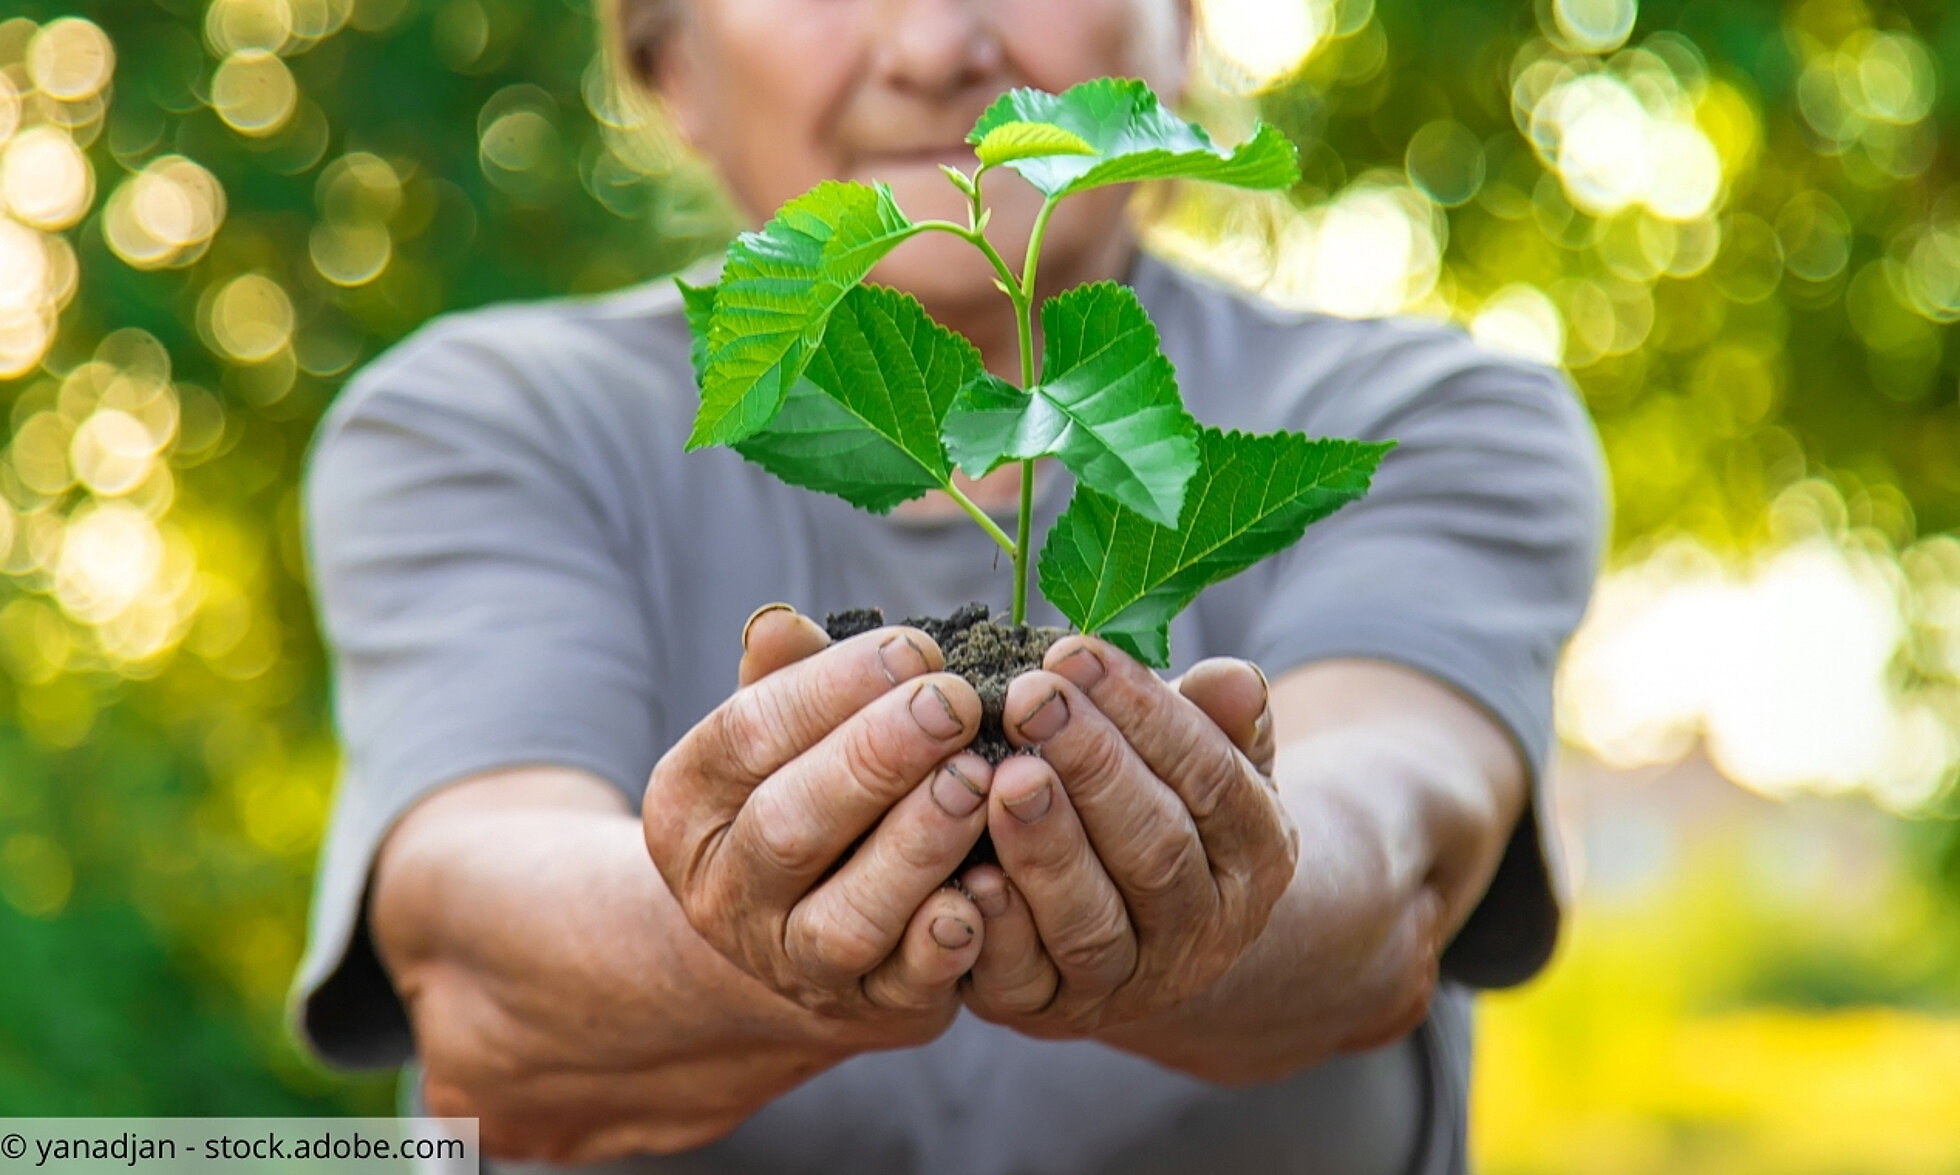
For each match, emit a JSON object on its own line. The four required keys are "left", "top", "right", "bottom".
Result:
{"left": 0, "top": 0, "right": 1960, "bottom": 1175}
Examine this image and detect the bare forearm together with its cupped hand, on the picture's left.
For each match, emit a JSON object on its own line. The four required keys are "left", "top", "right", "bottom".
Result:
{"left": 370, "top": 612, "right": 992, "bottom": 1163}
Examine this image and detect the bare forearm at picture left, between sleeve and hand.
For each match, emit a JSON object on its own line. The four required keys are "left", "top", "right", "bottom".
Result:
{"left": 372, "top": 768, "right": 853, "bottom": 1161}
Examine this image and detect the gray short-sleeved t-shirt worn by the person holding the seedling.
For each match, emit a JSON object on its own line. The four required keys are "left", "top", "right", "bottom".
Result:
{"left": 294, "top": 243, "right": 1605, "bottom": 1175}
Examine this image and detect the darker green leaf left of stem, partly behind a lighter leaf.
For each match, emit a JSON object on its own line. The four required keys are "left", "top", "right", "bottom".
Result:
{"left": 735, "top": 284, "right": 986, "bottom": 514}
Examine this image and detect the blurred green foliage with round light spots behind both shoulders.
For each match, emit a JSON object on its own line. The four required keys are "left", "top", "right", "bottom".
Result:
{"left": 0, "top": 0, "right": 1960, "bottom": 1145}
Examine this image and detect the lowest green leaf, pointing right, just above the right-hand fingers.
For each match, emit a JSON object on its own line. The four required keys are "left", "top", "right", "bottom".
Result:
{"left": 1041, "top": 428, "right": 1394, "bottom": 669}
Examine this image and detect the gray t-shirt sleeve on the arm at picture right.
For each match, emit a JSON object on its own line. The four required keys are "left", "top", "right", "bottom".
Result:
{"left": 1250, "top": 328, "right": 1609, "bottom": 987}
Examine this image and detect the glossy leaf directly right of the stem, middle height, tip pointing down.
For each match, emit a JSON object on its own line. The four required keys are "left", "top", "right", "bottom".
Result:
{"left": 947, "top": 282, "right": 1198, "bottom": 526}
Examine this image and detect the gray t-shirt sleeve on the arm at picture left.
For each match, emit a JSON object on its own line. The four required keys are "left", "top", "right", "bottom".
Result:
{"left": 290, "top": 320, "right": 659, "bottom": 1067}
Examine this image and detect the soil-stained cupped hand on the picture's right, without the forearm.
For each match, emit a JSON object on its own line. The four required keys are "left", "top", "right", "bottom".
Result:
{"left": 960, "top": 636, "right": 1299, "bottom": 1038}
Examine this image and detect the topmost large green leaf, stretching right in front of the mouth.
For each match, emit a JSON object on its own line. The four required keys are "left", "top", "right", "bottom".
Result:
{"left": 966, "top": 78, "right": 1299, "bottom": 196}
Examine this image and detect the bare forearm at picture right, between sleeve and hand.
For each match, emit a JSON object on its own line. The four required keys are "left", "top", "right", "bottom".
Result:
{"left": 1111, "top": 667, "right": 1523, "bottom": 1083}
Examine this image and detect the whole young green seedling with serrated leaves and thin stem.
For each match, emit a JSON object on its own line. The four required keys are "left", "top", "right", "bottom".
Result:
{"left": 680, "top": 78, "right": 1394, "bottom": 667}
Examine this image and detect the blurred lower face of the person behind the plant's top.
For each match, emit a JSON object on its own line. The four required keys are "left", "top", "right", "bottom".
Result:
{"left": 650, "top": 0, "right": 1190, "bottom": 308}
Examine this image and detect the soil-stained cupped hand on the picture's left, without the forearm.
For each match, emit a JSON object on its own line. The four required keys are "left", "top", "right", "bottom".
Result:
{"left": 641, "top": 608, "right": 992, "bottom": 1047}
